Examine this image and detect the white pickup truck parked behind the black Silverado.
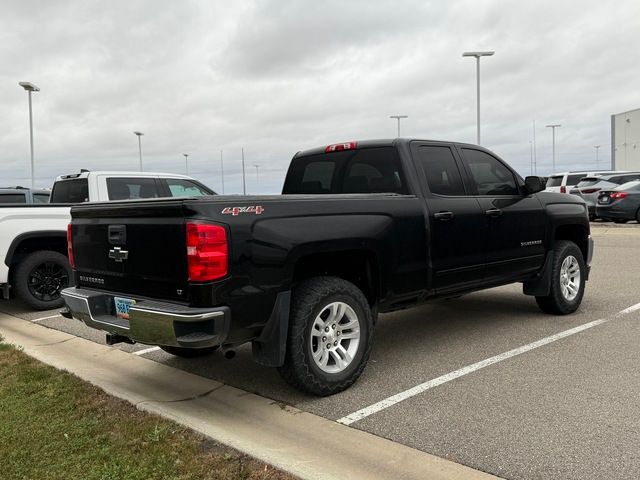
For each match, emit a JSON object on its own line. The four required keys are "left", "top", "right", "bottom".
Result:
{"left": 0, "top": 170, "right": 215, "bottom": 310}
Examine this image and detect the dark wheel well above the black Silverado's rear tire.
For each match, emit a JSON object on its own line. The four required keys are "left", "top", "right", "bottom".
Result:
{"left": 293, "top": 250, "right": 379, "bottom": 305}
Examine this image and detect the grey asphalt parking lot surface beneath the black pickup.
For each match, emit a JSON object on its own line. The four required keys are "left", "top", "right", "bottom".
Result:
{"left": 0, "top": 224, "right": 640, "bottom": 479}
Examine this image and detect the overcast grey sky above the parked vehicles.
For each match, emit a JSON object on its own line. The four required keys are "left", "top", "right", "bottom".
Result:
{"left": 0, "top": 0, "right": 640, "bottom": 193}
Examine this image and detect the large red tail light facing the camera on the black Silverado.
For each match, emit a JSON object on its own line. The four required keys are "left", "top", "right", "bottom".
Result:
{"left": 186, "top": 223, "right": 229, "bottom": 282}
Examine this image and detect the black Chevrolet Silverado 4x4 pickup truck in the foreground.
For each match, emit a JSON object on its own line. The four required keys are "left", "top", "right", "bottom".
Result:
{"left": 63, "top": 139, "right": 593, "bottom": 395}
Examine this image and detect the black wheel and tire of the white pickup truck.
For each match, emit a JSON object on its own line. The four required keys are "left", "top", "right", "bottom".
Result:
{"left": 14, "top": 250, "right": 73, "bottom": 310}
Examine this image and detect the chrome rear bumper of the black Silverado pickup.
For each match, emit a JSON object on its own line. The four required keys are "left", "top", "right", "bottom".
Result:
{"left": 62, "top": 287, "right": 231, "bottom": 348}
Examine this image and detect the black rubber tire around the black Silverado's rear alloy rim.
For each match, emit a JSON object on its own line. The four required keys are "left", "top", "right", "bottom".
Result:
{"left": 278, "top": 277, "right": 374, "bottom": 396}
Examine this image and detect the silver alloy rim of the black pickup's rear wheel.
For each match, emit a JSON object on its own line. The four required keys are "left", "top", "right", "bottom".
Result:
{"left": 309, "top": 302, "right": 360, "bottom": 373}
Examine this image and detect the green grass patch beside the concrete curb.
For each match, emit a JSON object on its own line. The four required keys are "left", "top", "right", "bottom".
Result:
{"left": 0, "top": 343, "right": 292, "bottom": 480}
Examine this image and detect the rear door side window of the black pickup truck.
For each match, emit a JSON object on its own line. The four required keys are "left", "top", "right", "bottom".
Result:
{"left": 418, "top": 146, "right": 465, "bottom": 195}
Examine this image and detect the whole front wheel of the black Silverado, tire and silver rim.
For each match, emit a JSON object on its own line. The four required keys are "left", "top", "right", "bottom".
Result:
{"left": 536, "top": 240, "right": 586, "bottom": 315}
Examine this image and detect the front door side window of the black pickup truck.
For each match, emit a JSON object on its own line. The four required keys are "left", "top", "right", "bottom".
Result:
{"left": 462, "top": 148, "right": 520, "bottom": 195}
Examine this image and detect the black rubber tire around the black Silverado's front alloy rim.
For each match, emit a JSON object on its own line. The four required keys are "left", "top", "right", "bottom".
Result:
{"left": 536, "top": 240, "right": 587, "bottom": 315}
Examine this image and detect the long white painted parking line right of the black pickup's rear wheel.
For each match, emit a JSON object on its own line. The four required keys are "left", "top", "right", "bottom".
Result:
{"left": 338, "top": 303, "right": 640, "bottom": 425}
